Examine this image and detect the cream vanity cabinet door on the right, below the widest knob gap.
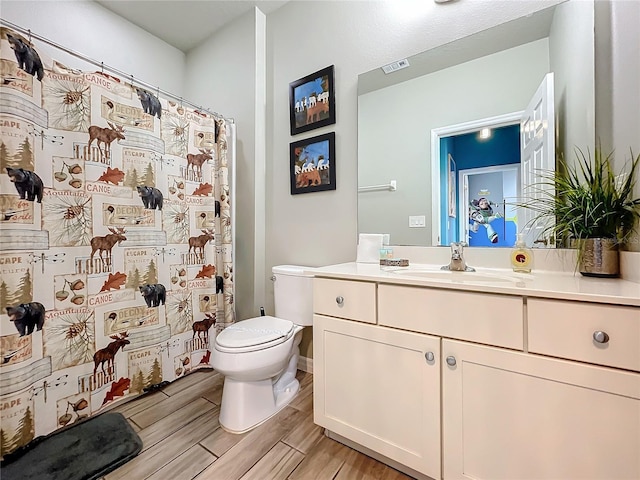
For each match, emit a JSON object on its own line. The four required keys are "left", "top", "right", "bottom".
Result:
{"left": 442, "top": 340, "right": 640, "bottom": 480}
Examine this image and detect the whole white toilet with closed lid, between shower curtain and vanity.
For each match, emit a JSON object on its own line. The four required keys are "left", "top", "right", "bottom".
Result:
{"left": 211, "top": 265, "right": 313, "bottom": 433}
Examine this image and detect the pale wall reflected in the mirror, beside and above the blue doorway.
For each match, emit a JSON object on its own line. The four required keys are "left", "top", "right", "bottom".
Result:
{"left": 358, "top": 38, "right": 549, "bottom": 245}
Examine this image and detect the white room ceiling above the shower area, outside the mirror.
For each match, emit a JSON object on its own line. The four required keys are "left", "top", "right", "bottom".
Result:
{"left": 95, "top": 0, "right": 287, "bottom": 53}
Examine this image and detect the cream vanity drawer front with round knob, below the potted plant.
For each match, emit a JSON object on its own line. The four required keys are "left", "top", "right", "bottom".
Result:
{"left": 527, "top": 298, "right": 640, "bottom": 371}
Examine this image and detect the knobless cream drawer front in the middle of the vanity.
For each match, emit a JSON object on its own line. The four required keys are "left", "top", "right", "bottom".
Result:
{"left": 378, "top": 285, "right": 524, "bottom": 350}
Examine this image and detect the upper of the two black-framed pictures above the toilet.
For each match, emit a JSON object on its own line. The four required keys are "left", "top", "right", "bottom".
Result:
{"left": 289, "top": 65, "right": 336, "bottom": 135}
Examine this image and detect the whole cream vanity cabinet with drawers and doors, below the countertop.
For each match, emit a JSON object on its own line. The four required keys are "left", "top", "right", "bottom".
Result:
{"left": 314, "top": 278, "right": 640, "bottom": 480}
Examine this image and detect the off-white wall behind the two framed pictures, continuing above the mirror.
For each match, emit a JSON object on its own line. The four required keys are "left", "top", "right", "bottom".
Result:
{"left": 266, "top": 0, "right": 558, "bottom": 282}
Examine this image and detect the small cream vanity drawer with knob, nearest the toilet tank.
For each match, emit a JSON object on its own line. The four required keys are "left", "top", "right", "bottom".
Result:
{"left": 313, "top": 278, "right": 376, "bottom": 323}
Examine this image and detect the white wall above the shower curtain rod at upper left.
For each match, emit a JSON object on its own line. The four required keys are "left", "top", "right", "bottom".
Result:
{"left": 0, "top": 0, "right": 185, "bottom": 95}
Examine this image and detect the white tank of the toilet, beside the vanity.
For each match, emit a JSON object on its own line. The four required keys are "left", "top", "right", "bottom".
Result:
{"left": 271, "top": 265, "right": 313, "bottom": 326}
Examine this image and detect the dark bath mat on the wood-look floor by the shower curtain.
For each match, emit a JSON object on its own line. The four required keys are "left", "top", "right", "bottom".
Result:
{"left": 0, "top": 413, "right": 142, "bottom": 480}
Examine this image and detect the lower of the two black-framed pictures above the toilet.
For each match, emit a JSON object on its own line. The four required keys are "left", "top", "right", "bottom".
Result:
{"left": 289, "top": 132, "right": 336, "bottom": 195}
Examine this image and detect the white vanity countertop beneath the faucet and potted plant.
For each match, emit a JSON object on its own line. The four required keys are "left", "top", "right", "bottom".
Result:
{"left": 309, "top": 262, "right": 640, "bottom": 308}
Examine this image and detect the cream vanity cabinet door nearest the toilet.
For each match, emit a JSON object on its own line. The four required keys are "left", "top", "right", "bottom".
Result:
{"left": 313, "top": 315, "right": 440, "bottom": 479}
